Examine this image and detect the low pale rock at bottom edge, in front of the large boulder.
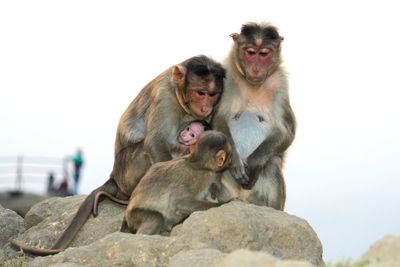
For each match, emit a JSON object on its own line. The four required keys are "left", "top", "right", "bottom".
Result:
{"left": 216, "top": 249, "right": 313, "bottom": 267}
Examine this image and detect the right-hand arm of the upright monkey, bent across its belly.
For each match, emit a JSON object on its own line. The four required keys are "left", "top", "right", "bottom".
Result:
{"left": 246, "top": 103, "right": 296, "bottom": 188}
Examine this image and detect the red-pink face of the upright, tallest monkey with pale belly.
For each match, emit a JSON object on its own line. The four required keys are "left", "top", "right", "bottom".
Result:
{"left": 241, "top": 44, "right": 274, "bottom": 84}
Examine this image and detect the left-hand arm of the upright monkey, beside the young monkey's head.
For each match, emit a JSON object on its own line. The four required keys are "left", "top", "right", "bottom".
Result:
{"left": 212, "top": 115, "right": 249, "bottom": 184}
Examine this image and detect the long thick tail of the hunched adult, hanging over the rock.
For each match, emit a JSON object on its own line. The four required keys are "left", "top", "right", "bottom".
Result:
{"left": 10, "top": 179, "right": 118, "bottom": 256}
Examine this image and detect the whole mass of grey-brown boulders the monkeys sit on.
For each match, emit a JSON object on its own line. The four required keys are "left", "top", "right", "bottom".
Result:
{"left": 3, "top": 196, "right": 324, "bottom": 267}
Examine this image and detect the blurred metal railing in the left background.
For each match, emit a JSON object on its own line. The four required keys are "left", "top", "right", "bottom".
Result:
{"left": 0, "top": 155, "right": 69, "bottom": 195}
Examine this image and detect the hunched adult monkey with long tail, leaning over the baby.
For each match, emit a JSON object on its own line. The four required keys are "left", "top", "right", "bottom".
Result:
{"left": 10, "top": 55, "right": 225, "bottom": 255}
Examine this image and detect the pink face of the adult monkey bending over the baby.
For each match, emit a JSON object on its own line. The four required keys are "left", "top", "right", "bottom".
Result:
{"left": 188, "top": 82, "right": 220, "bottom": 119}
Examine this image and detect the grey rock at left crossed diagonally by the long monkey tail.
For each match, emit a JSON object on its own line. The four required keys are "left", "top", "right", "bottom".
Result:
{"left": 12, "top": 196, "right": 124, "bottom": 248}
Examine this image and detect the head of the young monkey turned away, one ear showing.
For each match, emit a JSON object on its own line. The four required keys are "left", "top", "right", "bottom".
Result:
{"left": 189, "top": 130, "right": 232, "bottom": 171}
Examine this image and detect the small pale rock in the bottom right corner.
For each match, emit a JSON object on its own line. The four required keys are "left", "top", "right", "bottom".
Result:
{"left": 353, "top": 235, "right": 400, "bottom": 267}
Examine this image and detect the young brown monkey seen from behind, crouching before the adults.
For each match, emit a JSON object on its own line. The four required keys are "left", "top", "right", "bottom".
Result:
{"left": 121, "top": 131, "right": 231, "bottom": 235}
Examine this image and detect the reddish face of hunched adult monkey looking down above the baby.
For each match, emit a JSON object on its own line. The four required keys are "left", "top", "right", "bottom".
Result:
{"left": 187, "top": 77, "right": 221, "bottom": 119}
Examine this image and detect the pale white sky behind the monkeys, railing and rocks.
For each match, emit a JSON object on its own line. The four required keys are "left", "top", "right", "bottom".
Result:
{"left": 0, "top": 0, "right": 400, "bottom": 260}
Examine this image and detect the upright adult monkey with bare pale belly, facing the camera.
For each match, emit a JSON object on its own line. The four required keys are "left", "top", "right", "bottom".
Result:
{"left": 212, "top": 23, "right": 296, "bottom": 210}
